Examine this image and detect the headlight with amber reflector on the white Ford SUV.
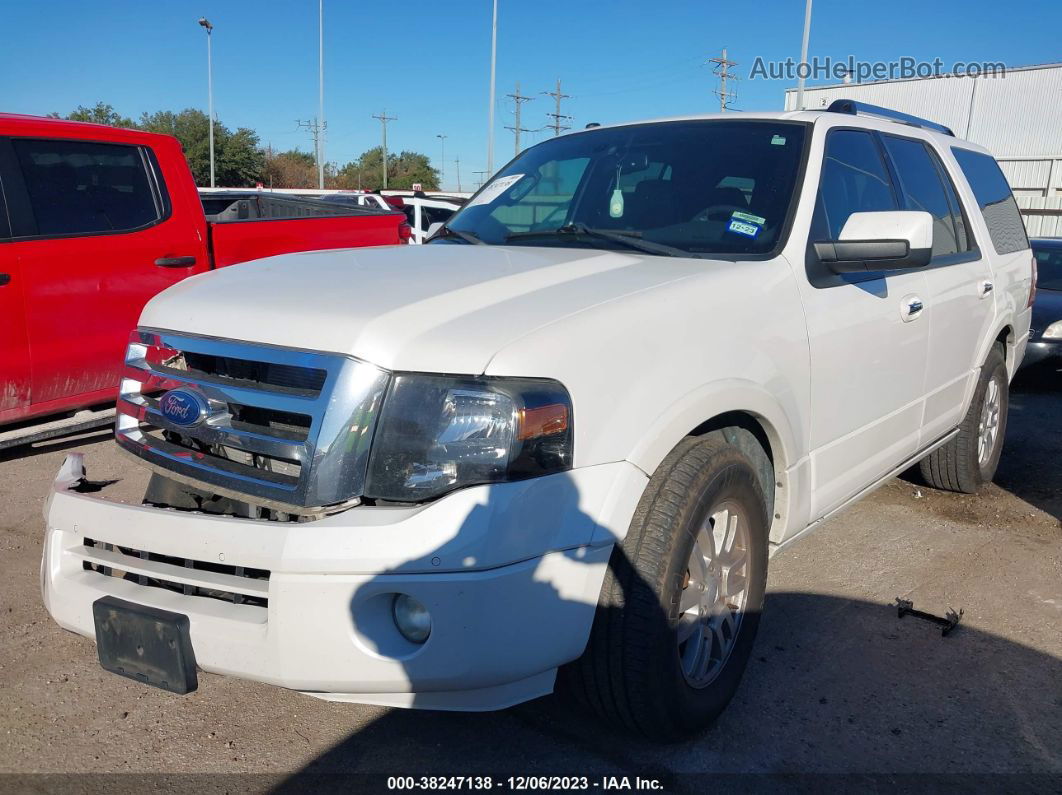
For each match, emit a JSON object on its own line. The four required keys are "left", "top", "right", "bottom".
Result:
{"left": 365, "top": 375, "right": 572, "bottom": 502}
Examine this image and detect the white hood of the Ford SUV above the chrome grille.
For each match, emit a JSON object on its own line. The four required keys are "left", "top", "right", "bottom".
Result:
{"left": 140, "top": 244, "right": 712, "bottom": 375}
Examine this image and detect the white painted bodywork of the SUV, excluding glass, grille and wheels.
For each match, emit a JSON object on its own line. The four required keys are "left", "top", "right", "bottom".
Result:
{"left": 41, "top": 108, "right": 1029, "bottom": 709}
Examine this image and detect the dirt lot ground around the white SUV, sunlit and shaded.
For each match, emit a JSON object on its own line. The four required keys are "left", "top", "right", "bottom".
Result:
{"left": 0, "top": 367, "right": 1062, "bottom": 792}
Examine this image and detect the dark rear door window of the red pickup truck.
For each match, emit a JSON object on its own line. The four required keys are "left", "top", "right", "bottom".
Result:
{"left": 12, "top": 138, "right": 164, "bottom": 237}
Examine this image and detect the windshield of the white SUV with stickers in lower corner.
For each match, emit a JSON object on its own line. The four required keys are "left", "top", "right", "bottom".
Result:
{"left": 436, "top": 120, "right": 807, "bottom": 256}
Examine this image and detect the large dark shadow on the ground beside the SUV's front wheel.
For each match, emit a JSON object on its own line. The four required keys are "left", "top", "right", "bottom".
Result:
{"left": 279, "top": 592, "right": 1062, "bottom": 792}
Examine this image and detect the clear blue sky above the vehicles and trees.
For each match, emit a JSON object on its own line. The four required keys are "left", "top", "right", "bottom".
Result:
{"left": 0, "top": 0, "right": 1062, "bottom": 190}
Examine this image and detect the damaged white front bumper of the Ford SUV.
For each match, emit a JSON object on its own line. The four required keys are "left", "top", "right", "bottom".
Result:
{"left": 41, "top": 456, "right": 647, "bottom": 710}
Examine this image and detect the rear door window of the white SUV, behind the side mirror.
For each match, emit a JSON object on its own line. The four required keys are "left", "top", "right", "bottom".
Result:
{"left": 883, "top": 135, "right": 970, "bottom": 257}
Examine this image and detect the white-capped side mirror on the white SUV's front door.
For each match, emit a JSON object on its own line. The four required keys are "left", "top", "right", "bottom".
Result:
{"left": 815, "top": 210, "right": 932, "bottom": 274}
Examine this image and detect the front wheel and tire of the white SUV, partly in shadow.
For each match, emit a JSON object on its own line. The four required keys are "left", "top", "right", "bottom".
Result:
{"left": 562, "top": 431, "right": 769, "bottom": 740}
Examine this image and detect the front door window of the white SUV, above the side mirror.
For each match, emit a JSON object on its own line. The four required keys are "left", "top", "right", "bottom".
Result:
{"left": 813, "top": 129, "right": 900, "bottom": 240}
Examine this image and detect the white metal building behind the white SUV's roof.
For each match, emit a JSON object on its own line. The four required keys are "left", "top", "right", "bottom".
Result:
{"left": 786, "top": 64, "right": 1062, "bottom": 236}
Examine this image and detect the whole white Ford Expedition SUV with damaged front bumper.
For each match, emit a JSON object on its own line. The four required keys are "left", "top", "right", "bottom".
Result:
{"left": 42, "top": 103, "right": 1034, "bottom": 737}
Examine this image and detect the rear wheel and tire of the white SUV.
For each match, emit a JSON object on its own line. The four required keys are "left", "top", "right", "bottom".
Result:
{"left": 919, "top": 344, "right": 1010, "bottom": 495}
